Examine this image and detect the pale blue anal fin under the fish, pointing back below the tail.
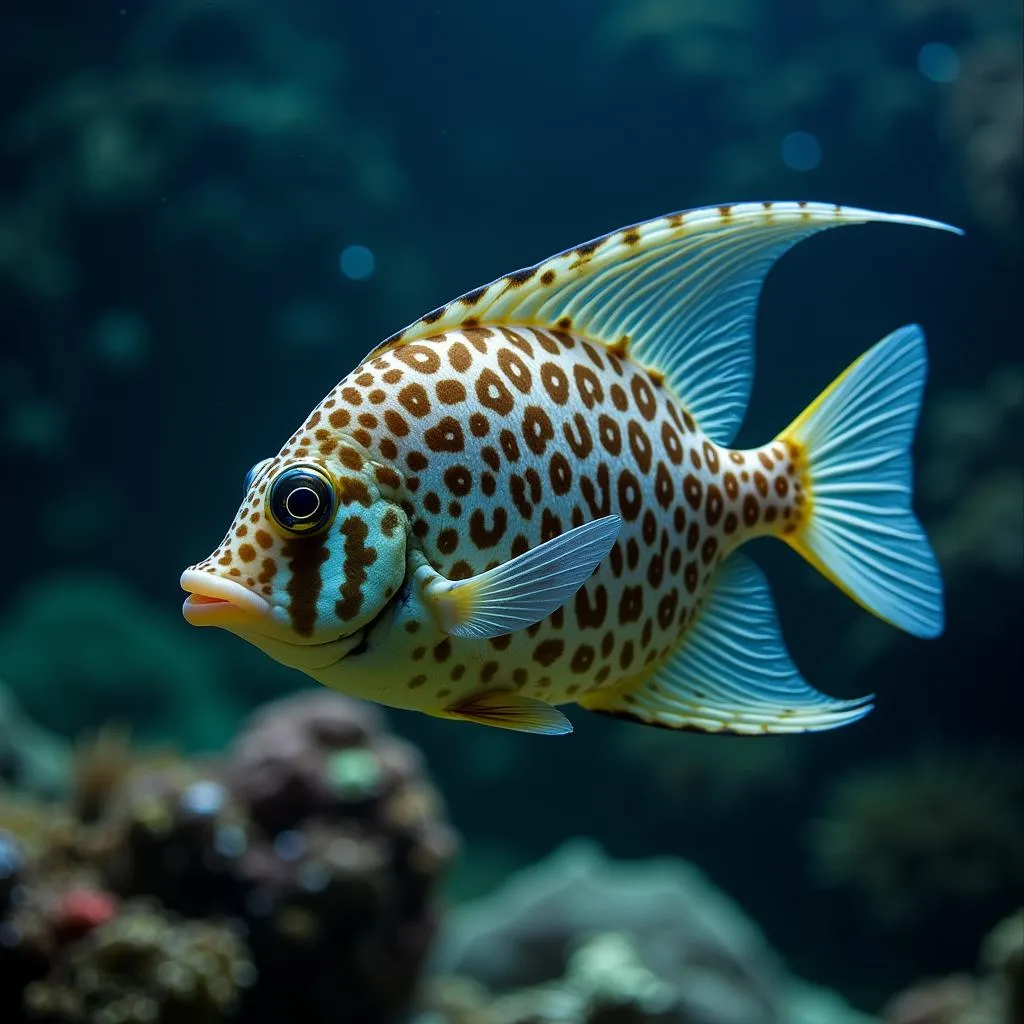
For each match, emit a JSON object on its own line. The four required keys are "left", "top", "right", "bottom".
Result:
{"left": 581, "top": 553, "right": 870, "bottom": 735}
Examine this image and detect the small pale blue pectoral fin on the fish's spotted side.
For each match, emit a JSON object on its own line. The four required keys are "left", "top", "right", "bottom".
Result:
{"left": 424, "top": 515, "right": 622, "bottom": 639}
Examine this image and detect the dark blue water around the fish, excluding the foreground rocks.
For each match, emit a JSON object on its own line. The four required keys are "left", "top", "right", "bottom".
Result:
{"left": 0, "top": 0, "right": 1024, "bottom": 1005}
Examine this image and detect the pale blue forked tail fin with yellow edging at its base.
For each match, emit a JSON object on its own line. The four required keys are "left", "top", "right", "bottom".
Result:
{"left": 779, "top": 325, "right": 945, "bottom": 637}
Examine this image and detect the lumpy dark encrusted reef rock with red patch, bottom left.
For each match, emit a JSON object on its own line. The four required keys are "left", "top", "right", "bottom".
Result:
{"left": 0, "top": 691, "right": 455, "bottom": 1024}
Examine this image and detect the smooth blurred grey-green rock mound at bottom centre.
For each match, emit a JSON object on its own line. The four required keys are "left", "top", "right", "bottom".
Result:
{"left": 422, "top": 841, "right": 870, "bottom": 1024}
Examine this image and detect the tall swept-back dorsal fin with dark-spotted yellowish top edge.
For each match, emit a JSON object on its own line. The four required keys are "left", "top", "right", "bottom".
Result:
{"left": 371, "top": 203, "right": 957, "bottom": 444}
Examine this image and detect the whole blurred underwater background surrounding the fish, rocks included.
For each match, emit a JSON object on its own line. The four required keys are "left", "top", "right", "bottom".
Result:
{"left": 0, "top": 0, "right": 1024, "bottom": 1024}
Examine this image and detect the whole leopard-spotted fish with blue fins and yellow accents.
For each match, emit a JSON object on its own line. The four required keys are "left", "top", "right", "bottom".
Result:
{"left": 181, "top": 202, "right": 961, "bottom": 735}
